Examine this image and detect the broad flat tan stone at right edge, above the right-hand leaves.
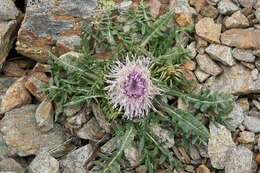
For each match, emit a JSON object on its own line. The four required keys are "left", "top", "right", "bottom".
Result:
{"left": 207, "top": 64, "right": 260, "bottom": 95}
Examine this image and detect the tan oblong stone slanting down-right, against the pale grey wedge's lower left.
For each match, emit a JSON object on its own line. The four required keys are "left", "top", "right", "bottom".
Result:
{"left": 196, "top": 54, "right": 223, "bottom": 76}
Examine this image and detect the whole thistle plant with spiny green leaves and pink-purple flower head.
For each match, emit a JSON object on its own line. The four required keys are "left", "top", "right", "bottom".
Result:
{"left": 44, "top": 2, "right": 234, "bottom": 173}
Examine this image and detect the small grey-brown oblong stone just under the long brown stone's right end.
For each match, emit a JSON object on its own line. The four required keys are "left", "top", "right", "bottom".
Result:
{"left": 232, "top": 48, "right": 255, "bottom": 62}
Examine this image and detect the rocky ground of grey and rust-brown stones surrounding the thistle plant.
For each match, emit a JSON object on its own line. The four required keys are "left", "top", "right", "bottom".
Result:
{"left": 0, "top": 0, "right": 260, "bottom": 173}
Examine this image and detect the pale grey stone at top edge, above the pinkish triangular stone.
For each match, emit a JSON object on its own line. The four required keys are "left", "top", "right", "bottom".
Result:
{"left": 218, "top": 0, "right": 239, "bottom": 15}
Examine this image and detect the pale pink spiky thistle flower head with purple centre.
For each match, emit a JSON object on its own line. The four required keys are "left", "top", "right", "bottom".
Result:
{"left": 105, "top": 56, "right": 161, "bottom": 119}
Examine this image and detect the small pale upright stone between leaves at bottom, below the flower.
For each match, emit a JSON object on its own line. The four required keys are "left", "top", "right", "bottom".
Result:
{"left": 124, "top": 142, "right": 141, "bottom": 167}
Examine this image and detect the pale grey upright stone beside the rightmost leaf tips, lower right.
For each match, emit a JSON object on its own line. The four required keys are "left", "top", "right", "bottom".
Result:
{"left": 228, "top": 103, "right": 244, "bottom": 128}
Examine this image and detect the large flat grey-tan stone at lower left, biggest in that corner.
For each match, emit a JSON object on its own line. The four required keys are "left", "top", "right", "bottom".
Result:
{"left": 0, "top": 105, "right": 73, "bottom": 157}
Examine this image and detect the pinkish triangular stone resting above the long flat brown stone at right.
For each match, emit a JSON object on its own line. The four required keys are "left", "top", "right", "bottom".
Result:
{"left": 224, "top": 11, "right": 249, "bottom": 28}
